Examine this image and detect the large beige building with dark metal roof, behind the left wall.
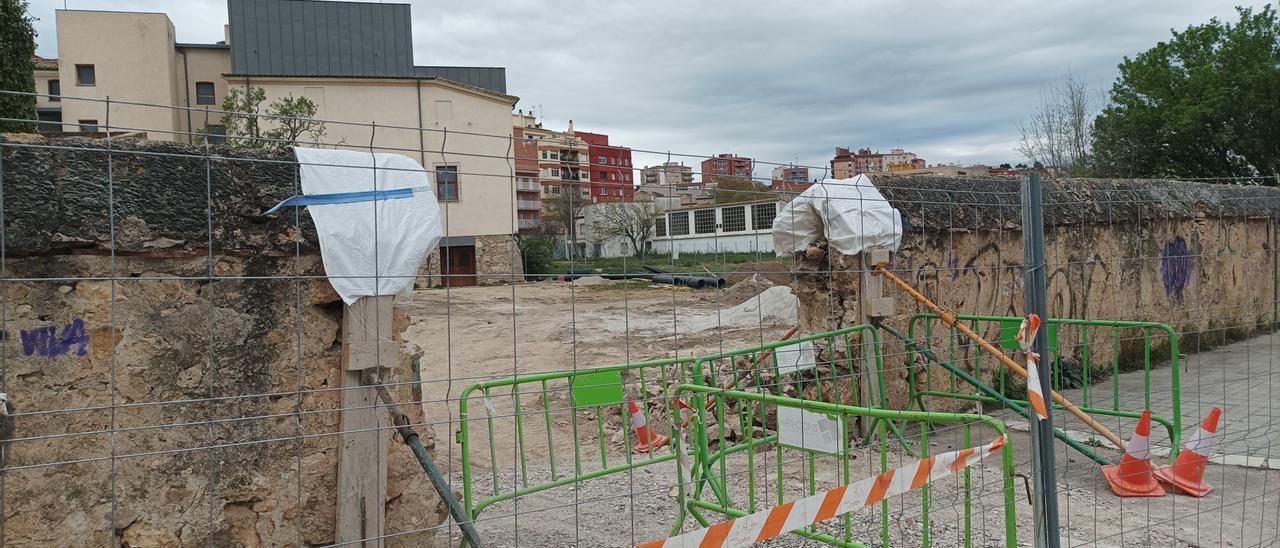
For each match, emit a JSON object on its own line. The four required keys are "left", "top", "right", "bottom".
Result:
{"left": 36, "top": 0, "right": 522, "bottom": 284}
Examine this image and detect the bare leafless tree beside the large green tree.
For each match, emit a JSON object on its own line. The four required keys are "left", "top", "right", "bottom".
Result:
{"left": 1018, "top": 73, "right": 1097, "bottom": 175}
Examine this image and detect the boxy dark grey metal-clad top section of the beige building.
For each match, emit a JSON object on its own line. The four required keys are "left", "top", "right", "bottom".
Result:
{"left": 227, "top": 0, "right": 415, "bottom": 78}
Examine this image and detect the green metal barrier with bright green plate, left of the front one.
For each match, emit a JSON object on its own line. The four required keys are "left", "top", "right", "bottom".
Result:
{"left": 456, "top": 325, "right": 893, "bottom": 530}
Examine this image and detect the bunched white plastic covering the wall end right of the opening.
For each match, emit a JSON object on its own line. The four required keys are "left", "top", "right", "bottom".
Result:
{"left": 773, "top": 175, "right": 902, "bottom": 257}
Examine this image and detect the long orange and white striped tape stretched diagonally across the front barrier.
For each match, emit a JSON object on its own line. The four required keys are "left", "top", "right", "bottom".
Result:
{"left": 637, "top": 437, "right": 1005, "bottom": 548}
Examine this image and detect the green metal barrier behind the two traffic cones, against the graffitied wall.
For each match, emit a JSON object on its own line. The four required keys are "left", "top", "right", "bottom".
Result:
{"left": 906, "top": 314, "right": 1183, "bottom": 462}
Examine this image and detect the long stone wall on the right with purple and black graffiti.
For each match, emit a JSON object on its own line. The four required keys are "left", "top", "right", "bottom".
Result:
{"left": 796, "top": 177, "right": 1280, "bottom": 410}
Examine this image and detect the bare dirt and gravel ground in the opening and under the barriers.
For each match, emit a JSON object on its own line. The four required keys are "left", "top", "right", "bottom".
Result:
{"left": 394, "top": 282, "right": 1280, "bottom": 547}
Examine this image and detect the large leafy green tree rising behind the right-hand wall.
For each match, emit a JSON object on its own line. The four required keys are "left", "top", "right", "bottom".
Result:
{"left": 1093, "top": 5, "right": 1280, "bottom": 178}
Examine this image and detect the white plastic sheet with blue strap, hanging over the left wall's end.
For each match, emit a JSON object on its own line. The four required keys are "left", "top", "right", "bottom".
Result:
{"left": 293, "top": 147, "right": 444, "bottom": 305}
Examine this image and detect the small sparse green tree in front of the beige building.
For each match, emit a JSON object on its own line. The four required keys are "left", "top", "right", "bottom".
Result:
{"left": 223, "top": 87, "right": 325, "bottom": 149}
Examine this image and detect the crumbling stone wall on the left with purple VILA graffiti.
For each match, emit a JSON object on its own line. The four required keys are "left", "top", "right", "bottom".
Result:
{"left": 0, "top": 137, "right": 444, "bottom": 547}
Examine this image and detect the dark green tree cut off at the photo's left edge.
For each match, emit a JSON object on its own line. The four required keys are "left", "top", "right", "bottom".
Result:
{"left": 0, "top": 0, "right": 36, "bottom": 133}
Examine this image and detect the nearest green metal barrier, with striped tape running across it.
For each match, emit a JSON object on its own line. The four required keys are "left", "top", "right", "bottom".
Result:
{"left": 672, "top": 384, "right": 1018, "bottom": 547}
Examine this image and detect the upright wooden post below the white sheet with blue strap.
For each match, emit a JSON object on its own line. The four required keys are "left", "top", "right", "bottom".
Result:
{"left": 335, "top": 296, "right": 399, "bottom": 547}
